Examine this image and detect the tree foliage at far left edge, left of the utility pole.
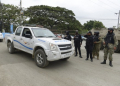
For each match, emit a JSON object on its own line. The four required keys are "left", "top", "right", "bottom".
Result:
{"left": 0, "top": 4, "right": 19, "bottom": 31}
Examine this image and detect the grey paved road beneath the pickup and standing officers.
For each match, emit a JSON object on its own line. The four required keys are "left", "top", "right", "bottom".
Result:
{"left": 0, "top": 42, "right": 120, "bottom": 86}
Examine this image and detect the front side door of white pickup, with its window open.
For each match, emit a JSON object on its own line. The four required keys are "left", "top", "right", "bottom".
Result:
{"left": 20, "top": 28, "right": 34, "bottom": 53}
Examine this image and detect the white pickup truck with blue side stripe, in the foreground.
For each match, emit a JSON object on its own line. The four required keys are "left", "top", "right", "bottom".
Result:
{"left": 5, "top": 26, "right": 74, "bottom": 67}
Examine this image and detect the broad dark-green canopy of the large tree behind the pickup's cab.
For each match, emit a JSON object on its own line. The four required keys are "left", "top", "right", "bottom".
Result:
{"left": 25, "top": 5, "right": 82, "bottom": 30}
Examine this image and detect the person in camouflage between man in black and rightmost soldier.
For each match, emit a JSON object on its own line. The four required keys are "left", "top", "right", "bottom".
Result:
{"left": 92, "top": 32, "right": 102, "bottom": 60}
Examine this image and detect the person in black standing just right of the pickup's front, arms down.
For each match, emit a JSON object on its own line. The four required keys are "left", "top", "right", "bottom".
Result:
{"left": 74, "top": 31, "right": 82, "bottom": 58}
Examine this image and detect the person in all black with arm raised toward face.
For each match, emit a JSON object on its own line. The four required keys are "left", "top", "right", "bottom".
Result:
{"left": 84, "top": 31, "right": 93, "bottom": 62}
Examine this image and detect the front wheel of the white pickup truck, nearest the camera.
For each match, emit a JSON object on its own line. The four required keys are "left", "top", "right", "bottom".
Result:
{"left": 34, "top": 49, "right": 49, "bottom": 68}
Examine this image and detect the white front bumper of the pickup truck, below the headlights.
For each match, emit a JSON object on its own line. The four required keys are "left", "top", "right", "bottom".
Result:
{"left": 46, "top": 48, "right": 74, "bottom": 61}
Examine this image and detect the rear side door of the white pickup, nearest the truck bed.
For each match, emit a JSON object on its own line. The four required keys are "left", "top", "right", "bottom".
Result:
{"left": 13, "top": 27, "right": 22, "bottom": 49}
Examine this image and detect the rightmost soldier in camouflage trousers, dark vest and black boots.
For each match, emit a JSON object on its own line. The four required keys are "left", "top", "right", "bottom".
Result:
{"left": 101, "top": 28, "right": 117, "bottom": 67}
